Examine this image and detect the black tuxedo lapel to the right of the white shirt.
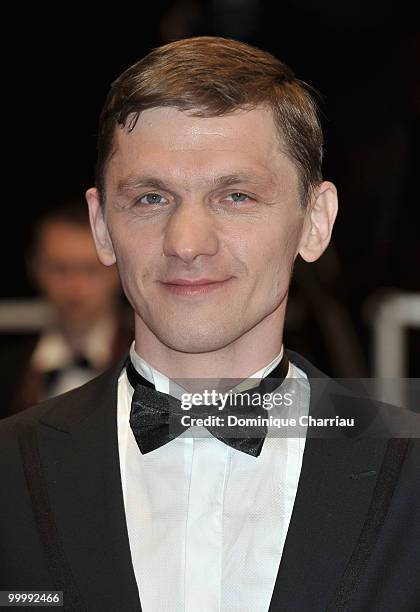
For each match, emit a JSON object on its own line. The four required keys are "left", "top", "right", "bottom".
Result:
{"left": 269, "top": 352, "right": 396, "bottom": 612}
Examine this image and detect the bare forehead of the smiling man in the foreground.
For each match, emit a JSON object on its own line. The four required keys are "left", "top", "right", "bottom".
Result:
{"left": 108, "top": 107, "right": 294, "bottom": 182}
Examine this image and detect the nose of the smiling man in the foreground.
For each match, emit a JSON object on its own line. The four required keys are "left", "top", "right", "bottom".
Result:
{"left": 163, "top": 202, "right": 219, "bottom": 263}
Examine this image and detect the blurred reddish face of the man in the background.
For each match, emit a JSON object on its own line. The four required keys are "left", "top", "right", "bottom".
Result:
{"left": 31, "top": 220, "right": 119, "bottom": 332}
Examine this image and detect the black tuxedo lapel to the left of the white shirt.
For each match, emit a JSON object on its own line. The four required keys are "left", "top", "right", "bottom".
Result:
{"left": 21, "top": 360, "right": 141, "bottom": 612}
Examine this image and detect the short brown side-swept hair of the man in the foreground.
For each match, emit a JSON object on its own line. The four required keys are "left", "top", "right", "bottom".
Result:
{"left": 96, "top": 36, "right": 323, "bottom": 206}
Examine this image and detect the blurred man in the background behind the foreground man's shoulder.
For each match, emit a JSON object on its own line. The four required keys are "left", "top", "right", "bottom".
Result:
{"left": 0, "top": 199, "right": 132, "bottom": 416}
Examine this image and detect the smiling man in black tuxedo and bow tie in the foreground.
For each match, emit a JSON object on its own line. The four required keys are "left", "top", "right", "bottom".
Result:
{"left": 1, "top": 37, "right": 419, "bottom": 612}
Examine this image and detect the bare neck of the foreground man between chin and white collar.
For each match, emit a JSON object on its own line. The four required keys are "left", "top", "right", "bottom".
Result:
{"left": 135, "top": 308, "right": 284, "bottom": 379}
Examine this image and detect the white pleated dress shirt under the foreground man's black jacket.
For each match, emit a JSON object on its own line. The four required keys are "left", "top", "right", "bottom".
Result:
{"left": 118, "top": 344, "right": 309, "bottom": 612}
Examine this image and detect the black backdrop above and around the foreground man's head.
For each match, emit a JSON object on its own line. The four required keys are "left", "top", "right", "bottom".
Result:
{"left": 1, "top": 0, "right": 420, "bottom": 376}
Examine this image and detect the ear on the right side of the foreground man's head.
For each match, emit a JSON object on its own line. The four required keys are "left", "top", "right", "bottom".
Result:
{"left": 298, "top": 181, "right": 338, "bottom": 262}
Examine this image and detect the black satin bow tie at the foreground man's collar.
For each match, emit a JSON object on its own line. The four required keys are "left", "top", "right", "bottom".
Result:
{"left": 126, "top": 353, "right": 289, "bottom": 457}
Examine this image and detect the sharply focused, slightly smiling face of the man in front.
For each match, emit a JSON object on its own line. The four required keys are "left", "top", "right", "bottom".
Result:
{"left": 88, "top": 108, "right": 312, "bottom": 353}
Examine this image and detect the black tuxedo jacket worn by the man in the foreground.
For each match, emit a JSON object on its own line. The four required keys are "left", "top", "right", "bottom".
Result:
{"left": 0, "top": 352, "right": 420, "bottom": 612}
